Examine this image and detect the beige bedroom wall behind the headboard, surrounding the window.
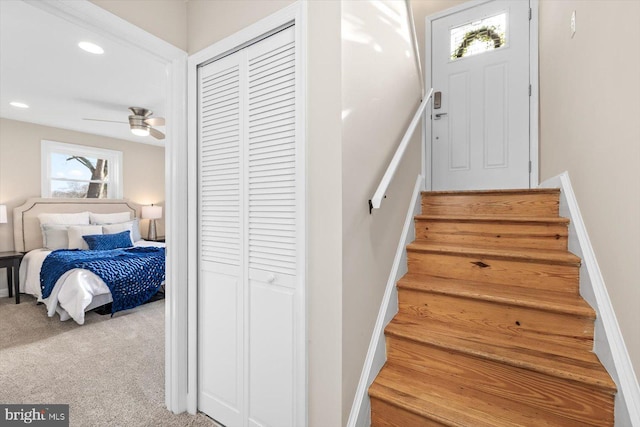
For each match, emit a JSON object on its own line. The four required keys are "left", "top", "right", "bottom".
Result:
{"left": 0, "top": 119, "right": 164, "bottom": 264}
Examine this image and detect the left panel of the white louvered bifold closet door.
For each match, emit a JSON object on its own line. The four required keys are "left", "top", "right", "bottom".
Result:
{"left": 198, "top": 48, "right": 245, "bottom": 426}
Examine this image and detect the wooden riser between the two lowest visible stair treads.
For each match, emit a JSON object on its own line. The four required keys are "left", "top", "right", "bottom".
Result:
{"left": 387, "top": 337, "right": 614, "bottom": 425}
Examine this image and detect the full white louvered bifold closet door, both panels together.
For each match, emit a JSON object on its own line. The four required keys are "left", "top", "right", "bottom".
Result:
{"left": 198, "top": 27, "right": 304, "bottom": 427}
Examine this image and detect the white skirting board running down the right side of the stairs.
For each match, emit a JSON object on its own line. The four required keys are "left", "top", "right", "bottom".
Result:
{"left": 540, "top": 172, "right": 640, "bottom": 427}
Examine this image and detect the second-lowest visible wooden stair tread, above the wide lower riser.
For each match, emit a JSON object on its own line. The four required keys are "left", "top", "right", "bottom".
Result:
{"left": 385, "top": 313, "right": 616, "bottom": 393}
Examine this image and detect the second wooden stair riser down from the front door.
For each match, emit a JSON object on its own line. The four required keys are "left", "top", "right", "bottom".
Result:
{"left": 415, "top": 219, "right": 568, "bottom": 250}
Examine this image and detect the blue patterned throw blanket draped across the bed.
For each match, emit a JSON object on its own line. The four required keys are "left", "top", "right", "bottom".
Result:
{"left": 40, "top": 247, "right": 165, "bottom": 314}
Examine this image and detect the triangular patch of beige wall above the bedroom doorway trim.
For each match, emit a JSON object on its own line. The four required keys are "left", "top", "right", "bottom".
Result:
{"left": 90, "top": 0, "right": 189, "bottom": 52}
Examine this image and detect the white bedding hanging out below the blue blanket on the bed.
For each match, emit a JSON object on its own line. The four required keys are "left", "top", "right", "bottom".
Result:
{"left": 20, "top": 240, "right": 164, "bottom": 325}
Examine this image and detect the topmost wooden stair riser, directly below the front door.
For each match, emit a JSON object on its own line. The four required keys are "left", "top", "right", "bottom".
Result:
{"left": 422, "top": 192, "right": 559, "bottom": 217}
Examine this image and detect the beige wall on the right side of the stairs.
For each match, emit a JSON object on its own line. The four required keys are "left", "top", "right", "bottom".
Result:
{"left": 540, "top": 0, "right": 640, "bottom": 377}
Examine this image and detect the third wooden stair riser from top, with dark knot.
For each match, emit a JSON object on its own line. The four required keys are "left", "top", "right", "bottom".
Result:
{"left": 407, "top": 251, "right": 579, "bottom": 293}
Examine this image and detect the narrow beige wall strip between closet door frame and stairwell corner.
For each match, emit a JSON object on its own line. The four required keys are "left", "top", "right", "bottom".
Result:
{"left": 307, "top": 1, "right": 344, "bottom": 427}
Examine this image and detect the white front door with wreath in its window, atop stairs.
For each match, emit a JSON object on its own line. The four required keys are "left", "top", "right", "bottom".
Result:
{"left": 431, "top": 0, "right": 530, "bottom": 190}
